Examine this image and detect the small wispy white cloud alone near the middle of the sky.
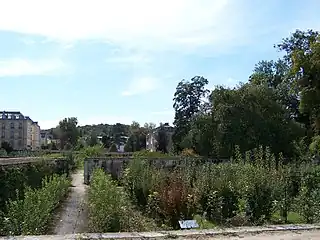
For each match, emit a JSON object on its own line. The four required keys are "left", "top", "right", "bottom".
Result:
{"left": 121, "top": 77, "right": 160, "bottom": 96}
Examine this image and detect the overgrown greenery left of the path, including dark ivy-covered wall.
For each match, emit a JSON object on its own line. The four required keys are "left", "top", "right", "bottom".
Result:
{"left": 0, "top": 159, "right": 69, "bottom": 235}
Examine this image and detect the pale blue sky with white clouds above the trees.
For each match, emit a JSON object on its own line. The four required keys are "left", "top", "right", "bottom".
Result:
{"left": 0, "top": 0, "right": 320, "bottom": 129}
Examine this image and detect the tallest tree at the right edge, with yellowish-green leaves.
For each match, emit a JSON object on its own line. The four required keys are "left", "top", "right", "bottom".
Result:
{"left": 276, "top": 30, "right": 320, "bottom": 134}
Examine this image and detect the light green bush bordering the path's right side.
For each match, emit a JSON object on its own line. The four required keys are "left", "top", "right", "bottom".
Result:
{"left": 88, "top": 169, "right": 155, "bottom": 232}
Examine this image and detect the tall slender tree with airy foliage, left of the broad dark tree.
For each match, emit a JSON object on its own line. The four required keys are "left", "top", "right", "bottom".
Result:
{"left": 172, "top": 76, "right": 208, "bottom": 152}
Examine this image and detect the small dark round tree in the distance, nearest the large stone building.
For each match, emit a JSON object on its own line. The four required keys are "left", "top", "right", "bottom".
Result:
{"left": 57, "top": 117, "right": 80, "bottom": 148}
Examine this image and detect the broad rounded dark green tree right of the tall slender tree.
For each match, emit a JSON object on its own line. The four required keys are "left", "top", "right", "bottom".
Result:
{"left": 212, "top": 84, "right": 304, "bottom": 157}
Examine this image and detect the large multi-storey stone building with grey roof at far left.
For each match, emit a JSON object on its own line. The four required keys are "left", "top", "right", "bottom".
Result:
{"left": 0, "top": 111, "right": 40, "bottom": 150}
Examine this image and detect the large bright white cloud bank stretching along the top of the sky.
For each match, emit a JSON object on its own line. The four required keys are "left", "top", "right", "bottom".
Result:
{"left": 0, "top": 0, "right": 253, "bottom": 51}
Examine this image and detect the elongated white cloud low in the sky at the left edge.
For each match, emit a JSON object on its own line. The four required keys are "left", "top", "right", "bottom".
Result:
{"left": 0, "top": 58, "right": 65, "bottom": 77}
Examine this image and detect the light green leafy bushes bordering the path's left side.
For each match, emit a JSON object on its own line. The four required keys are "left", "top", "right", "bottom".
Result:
{"left": 1, "top": 175, "right": 70, "bottom": 235}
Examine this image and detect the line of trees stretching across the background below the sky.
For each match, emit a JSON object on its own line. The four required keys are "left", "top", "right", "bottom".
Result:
{"left": 45, "top": 30, "right": 320, "bottom": 158}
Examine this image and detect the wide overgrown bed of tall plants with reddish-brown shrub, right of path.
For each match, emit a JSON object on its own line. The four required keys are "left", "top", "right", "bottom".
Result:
{"left": 122, "top": 147, "right": 320, "bottom": 229}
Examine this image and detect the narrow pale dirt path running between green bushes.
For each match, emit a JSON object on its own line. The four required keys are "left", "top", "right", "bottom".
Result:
{"left": 53, "top": 170, "right": 87, "bottom": 235}
